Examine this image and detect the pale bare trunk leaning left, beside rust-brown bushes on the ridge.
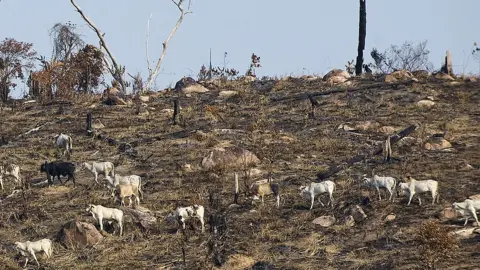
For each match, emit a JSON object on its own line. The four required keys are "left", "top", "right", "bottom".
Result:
{"left": 70, "top": 0, "right": 126, "bottom": 92}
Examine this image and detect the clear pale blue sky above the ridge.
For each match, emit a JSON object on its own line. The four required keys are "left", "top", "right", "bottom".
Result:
{"left": 0, "top": 0, "right": 480, "bottom": 97}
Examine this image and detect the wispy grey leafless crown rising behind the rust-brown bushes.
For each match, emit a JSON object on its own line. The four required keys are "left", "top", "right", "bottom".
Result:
{"left": 50, "top": 22, "right": 85, "bottom": 62}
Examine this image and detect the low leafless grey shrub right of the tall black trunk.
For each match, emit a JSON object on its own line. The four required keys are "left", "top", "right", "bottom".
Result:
{"left": 370, "top": 40, "right": 433, "bottom": 73}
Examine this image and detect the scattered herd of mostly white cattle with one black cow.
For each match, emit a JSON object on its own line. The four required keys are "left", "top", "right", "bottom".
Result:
{"left": 0, "top": 133, "right": 480, "bottom": 267}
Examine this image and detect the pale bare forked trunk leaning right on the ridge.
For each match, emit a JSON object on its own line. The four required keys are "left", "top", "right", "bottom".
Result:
{"left": 143, "top": 0, "right": 192, "bottom": 92}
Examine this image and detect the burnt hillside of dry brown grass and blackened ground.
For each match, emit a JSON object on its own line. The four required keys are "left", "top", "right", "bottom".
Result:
{"left": 0, "top": 73, "right": 480, "bottom": 269}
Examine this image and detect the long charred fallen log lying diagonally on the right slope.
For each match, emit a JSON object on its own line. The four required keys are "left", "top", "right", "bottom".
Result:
{"left": 317, "top": 125, "right": 417, "bottom": 181}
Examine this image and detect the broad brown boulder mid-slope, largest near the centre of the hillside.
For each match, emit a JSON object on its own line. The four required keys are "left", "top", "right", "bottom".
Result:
{"left": 202, "top": 146, "right": 260, "bottom": 170}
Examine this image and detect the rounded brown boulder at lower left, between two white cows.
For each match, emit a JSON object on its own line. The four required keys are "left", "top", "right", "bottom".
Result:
{"left": 59, "top": 220, "right": 103, "bottom": 249}
